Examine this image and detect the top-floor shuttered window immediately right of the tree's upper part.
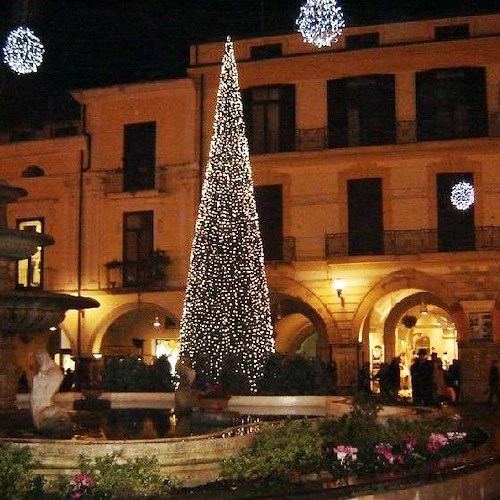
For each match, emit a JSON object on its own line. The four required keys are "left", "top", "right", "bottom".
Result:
{"left": 243, "top": 85, "right": 295, "bottom": 154}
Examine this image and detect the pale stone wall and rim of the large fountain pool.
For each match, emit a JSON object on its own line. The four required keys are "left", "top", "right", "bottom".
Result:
{"left": 6, "top": 392, "right": 418, "bottom": 486}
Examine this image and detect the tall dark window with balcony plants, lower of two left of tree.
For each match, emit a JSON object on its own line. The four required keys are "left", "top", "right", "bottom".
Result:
{"left": 123, "top": 210, "right": 153, "bottom": 287}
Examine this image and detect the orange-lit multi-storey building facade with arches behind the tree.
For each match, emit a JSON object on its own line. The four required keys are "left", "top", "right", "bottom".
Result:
{"left": 0, "top": 14, "right": 500, "bottom": 400}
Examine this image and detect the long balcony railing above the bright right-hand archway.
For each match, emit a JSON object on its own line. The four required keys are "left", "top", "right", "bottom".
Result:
{"left": 325, "top": 226, "right": 500, "bottom": 259}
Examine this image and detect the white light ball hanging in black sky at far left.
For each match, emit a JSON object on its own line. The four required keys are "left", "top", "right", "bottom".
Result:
{"left": 3, "top": 26, "right": 45, "bottom": 75}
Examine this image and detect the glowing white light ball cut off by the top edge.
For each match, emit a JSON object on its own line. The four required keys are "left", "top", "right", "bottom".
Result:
{"left": 295, "top": 0, "right": 345, "bottom": 48}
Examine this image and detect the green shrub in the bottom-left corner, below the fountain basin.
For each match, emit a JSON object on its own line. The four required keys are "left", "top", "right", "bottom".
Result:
{"left": 0, "top": 443, "right": 43, "bottom": 500}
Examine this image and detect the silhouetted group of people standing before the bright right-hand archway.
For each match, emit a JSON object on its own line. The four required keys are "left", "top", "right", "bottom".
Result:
{"left": 410, "top": 349, "right": 460, "bottom": 405}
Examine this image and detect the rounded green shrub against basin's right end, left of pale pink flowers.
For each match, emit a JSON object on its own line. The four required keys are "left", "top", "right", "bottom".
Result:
{"left": 221, "top": 420, "right": 323, "bottom": 480}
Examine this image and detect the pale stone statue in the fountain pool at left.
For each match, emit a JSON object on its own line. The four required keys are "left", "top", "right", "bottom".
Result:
{"left": 30, "top": 351, "right": 72, "bottom": 437}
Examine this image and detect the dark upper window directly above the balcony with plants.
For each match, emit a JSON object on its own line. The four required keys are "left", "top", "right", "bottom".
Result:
{"left": 123, "top": 122, "right": 156, "bottom": 192}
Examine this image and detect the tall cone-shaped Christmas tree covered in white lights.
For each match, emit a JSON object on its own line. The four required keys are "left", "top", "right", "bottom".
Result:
{"left": 180, "top": 37, "right": 274, "bottom": 391}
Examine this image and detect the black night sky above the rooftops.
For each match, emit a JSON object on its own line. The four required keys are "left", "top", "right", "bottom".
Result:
{"left": 0, "top": 0, "right": 500, "bottom": 127}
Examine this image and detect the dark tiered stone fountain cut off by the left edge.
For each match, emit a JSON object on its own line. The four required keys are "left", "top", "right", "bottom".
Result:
{"left": 0, "top": 182, "right": 99, "bottom": 411}
